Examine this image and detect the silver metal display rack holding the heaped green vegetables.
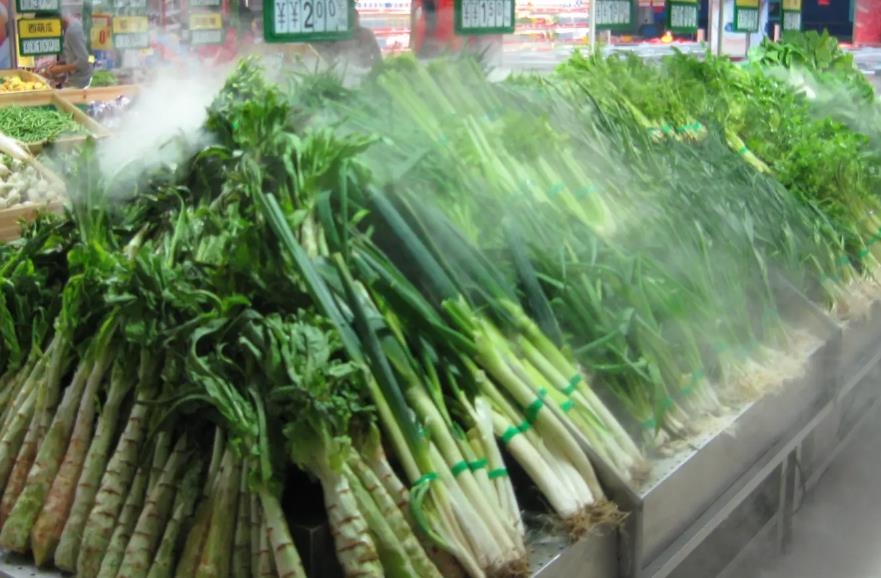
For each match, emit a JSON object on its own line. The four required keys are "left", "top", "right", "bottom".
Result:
{"left": 0, "top": 294, "right": 881, "bottom": 578}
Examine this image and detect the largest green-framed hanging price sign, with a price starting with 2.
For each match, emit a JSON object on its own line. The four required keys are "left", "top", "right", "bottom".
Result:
{"left": 263, "top": 0, "right": 355, "bottom": 43}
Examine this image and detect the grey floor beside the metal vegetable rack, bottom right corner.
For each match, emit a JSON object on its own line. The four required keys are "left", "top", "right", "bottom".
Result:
{"left": 755, "top": 410, "right": 881, "bottom": 578}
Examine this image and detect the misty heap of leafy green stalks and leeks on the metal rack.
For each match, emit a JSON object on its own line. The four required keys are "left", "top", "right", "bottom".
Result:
{"left": 0, "top": 31, "right": 877, "bottom": 578}
